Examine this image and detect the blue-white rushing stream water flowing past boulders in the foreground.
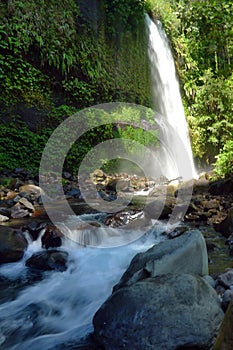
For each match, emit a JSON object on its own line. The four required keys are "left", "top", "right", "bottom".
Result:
{"left": 0, "top": 215, "right": 164, "bottom": 350}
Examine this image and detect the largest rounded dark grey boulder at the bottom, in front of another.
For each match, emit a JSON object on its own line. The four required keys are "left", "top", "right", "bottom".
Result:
{"left": 93, "top": 274, "right": 223, "bottom": 350}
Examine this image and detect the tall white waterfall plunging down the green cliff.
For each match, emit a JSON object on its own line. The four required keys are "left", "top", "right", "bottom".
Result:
{"left": 146, "top": 15, "right": 196, "bottom": 180}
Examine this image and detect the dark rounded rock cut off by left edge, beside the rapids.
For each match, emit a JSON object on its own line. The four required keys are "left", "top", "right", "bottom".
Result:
{"left": 0, "top": 226, "right": 28, "bottom": 264}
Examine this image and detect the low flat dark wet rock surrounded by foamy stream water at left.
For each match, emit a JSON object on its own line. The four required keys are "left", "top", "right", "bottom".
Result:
{"left": 26, "top": 250, "right": 68, "bottom": 272}
